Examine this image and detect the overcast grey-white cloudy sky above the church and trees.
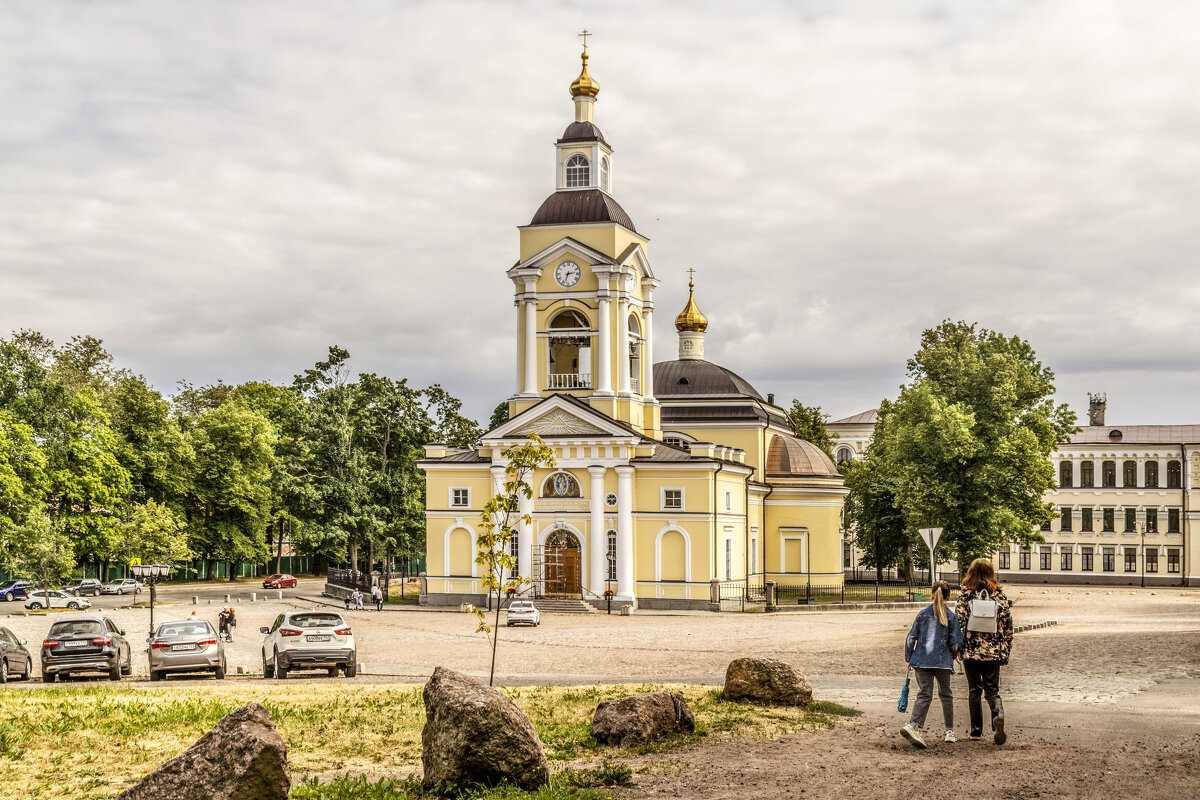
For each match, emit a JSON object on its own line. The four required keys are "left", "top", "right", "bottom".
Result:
{"left": 0, "top": 0, "right": 1200, "bottom": 423}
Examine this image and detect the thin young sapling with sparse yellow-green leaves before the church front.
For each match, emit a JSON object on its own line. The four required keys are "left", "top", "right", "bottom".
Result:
{"left": 475, "top": 435, "right": 554, "bottom": 686}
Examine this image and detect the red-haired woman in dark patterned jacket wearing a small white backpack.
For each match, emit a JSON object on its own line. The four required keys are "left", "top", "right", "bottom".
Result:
{"left": 955, "top": 559, "right": 1013, "bottom": 745}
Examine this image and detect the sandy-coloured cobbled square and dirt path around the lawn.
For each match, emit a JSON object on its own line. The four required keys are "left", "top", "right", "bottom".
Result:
{"left": 0, "top": 581, "right": 1200, "bottom": 800}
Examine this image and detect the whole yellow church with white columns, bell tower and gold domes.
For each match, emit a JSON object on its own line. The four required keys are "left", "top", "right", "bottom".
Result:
{"left": 419, "top": 49, "right": 846, "bottom": 610}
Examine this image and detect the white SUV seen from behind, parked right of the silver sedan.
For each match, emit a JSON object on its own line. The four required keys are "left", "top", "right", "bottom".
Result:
{"left": 258, "top": 610, "right": 359, "bottom": 678}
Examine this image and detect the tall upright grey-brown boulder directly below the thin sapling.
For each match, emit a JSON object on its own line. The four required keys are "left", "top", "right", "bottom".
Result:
{"left": 421, "top": 667, "right": 550, "bottom": 790}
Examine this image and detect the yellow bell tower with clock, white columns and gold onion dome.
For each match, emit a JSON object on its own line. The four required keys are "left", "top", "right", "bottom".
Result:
{"left": 508, "top": 37, "right": 660, "bottom": 437}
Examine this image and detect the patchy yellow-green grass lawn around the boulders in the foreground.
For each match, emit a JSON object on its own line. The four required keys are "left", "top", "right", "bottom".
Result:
{"left": 0, "top": 681, "right": 856, "bottom": 800}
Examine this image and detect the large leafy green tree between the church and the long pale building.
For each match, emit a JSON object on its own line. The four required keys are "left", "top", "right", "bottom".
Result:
{"left": 871, "top": 320, "right": 1075, "bottom": 569}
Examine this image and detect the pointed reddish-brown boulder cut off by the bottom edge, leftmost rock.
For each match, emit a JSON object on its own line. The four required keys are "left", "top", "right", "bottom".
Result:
{"left": 119, "top": 703, "right": 292, "bottom": 800}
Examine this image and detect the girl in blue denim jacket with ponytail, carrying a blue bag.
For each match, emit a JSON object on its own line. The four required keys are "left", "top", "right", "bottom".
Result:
{"left": 900, "top": 581, "right": 962, "bottom": 750}
